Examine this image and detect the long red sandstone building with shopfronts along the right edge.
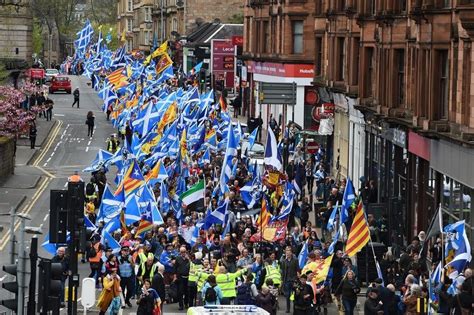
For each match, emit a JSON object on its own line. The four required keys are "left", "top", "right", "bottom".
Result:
{"left": 313, "top": 0, "right": 474, "bottom": 245}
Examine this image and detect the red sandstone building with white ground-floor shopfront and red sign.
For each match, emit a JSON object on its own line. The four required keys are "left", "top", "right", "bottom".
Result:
{"left": 241, "top": 0, "right": 317, "bottom": 131}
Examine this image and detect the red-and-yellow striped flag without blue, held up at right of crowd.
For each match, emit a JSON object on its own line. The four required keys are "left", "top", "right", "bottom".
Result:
{"left": 346, "top": 201, "right": 370, "bottom": 257}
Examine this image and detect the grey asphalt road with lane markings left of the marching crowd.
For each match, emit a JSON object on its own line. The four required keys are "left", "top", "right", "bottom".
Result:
{"left": 0, "top": 76, "right": 364, "bottom": 315}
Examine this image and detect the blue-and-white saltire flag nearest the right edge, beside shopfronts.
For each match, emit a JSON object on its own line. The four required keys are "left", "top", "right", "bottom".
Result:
{"left": 444, "top": 220, "right": 472, "bottom": 279}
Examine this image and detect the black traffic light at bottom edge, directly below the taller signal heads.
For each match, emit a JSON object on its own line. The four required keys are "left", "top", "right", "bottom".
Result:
{"left": 38, "top": 259, "right": 64, "bottom": 314}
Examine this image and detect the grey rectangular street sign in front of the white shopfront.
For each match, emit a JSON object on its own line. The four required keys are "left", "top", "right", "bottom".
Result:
{"left": 260, "top": 82, "right": 296, "bottom": 105}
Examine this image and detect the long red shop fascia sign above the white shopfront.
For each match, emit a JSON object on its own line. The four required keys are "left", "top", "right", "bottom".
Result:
{"left": 247, "top": 61, "right": 314, "bottom": 78}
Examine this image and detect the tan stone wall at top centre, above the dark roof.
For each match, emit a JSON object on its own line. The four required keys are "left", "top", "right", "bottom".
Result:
{"left": 185, "top": 0, "right": 244, "bottom": 34}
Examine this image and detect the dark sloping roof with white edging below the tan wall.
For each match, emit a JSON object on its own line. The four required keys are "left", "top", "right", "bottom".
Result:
{"left": 185, "top": 23, "right": 244, "bottom": 47}
